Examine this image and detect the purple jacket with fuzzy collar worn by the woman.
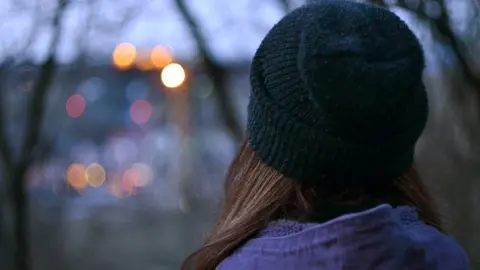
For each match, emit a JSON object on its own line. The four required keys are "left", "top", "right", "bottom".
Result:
{"left": 217, "top": 204, "right": 469, "bottom": 270}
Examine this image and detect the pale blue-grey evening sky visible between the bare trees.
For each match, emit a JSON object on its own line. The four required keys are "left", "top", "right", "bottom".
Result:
{"left": 0, "top": 0, "right": 467, "bottom": 62}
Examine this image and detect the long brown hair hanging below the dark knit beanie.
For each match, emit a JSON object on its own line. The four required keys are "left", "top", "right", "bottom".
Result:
{"left": 182, "top": 141, "right": 441, "bottom": 270}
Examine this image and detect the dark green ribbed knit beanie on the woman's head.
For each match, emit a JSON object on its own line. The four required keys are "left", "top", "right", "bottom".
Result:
{"left": 247, "top": 0, "right": 428, "bottom": 188}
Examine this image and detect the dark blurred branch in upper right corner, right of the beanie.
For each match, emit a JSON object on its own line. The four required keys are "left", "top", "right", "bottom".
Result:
{"left": 370, "top": 0, "right": 480, "bottom": 91}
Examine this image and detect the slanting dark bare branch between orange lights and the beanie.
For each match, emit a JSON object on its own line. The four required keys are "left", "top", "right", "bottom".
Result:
{"left": 175, "top": 0, "right": 243, "bottom": 141}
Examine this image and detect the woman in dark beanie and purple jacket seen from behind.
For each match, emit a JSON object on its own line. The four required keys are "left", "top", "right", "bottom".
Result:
{"left": 183, "top": 0, "right": 469, "bottom": 270}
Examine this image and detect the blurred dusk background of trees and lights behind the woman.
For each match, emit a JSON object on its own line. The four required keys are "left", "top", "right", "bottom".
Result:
{"left": 0, "top": 0, "right": 480, "bottom": 270}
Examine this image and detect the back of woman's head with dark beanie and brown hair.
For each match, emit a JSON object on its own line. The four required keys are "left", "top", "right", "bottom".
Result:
{"left": 184, "top": 0, "right": 439, "bottom": 270}
